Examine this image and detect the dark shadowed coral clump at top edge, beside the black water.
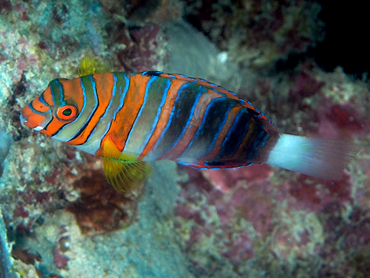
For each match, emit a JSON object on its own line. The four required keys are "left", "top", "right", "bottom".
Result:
{"left": 184, "top": 0, "right": 323, "bottom": 69}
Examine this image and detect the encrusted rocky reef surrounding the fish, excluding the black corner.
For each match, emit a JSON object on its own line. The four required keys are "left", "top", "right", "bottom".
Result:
{"left": 0, "top": 0, "right": 370, "bottom": 278}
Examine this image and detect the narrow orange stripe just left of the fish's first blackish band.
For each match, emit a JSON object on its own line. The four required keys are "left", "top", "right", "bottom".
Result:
{"left": 139, "top": 79, "right": 187, "bottom": 159}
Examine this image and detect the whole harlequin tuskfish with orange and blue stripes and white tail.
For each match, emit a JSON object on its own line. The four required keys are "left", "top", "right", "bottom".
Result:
{"left": 21, "top": 61, "right": 358, "bottom": 191}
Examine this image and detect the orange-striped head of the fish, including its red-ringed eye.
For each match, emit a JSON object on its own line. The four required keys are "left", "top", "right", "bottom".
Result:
{"left": 20, "top": 79, "right": 84, "bottom": 137}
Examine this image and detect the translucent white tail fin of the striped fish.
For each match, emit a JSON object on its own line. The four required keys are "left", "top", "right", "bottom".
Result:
{"left": 267, "top": 134, "right": 360, "bottom": 179}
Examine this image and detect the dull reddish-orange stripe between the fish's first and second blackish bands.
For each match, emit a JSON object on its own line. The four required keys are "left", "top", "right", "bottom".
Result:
{"left": 158, "top": 90, "right": 223, "bottom": 160}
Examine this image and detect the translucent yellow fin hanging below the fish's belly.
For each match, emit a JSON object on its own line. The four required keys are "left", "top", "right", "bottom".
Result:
{"left": 103, "top": 140, "right": 152, "bottom": 192}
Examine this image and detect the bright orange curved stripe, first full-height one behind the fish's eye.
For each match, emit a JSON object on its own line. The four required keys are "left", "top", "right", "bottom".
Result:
{"left": 68, "top": 73, "right": 114, "bottom": 145}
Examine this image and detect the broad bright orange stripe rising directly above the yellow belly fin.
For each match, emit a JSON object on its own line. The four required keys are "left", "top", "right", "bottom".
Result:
{"left": 107, "top": 74, "right": 151, "bottom": 152}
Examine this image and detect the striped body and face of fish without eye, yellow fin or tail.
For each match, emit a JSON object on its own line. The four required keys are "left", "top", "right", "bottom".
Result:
{"left": 22, "top": 72, "right": 279, "bottom": 168}
